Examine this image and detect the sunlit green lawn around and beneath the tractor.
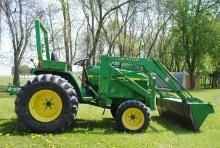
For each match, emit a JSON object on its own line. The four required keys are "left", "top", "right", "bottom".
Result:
{"left": 0, "top": 77, "right": 220, "bottom": 148}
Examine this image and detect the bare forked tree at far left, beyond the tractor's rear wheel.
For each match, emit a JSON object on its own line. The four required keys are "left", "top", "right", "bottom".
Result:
{"left": 1, "top": 0, "right": 42, "bottom": 85}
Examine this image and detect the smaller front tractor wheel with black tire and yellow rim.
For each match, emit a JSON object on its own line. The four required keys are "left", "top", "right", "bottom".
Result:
{"left": 115, "top": 100, "right": 151, "bottom": 133}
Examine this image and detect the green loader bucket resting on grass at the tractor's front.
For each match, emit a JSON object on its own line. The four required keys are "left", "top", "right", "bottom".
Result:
{"left": 157, "top": 98, "right": 214, "bottom": 131}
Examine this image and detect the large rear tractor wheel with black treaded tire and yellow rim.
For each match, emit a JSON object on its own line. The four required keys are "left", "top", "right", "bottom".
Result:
{"left": 15, "top": 74, "right": 78, "bottom": 133}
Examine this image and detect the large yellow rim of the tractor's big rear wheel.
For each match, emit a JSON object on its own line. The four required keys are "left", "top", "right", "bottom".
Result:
{"left": 29, "top": 89, "right": 62, "bottom": 122}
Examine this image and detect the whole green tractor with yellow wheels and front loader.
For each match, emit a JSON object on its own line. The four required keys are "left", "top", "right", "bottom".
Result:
{"left": 15, "top": 20, "right": 214, "bottom": 132}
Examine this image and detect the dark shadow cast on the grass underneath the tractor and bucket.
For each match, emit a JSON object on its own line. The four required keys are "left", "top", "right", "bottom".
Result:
{"left": 0, "top": 116, "right": 200, "bottom": 136}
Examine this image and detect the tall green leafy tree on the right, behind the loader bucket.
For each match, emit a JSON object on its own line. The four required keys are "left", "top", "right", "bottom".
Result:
{"left": 166, "top": 0, "right": 219, "bottom": 89}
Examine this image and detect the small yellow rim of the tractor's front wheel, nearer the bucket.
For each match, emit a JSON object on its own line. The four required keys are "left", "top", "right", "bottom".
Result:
{"left": 122, "top": 108, "right": 144, "bottom": 130}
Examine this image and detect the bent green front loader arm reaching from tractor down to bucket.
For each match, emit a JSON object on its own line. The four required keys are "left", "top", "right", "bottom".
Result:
{"left": 100, "top": 56, "right": 193, "bottom": 101}
